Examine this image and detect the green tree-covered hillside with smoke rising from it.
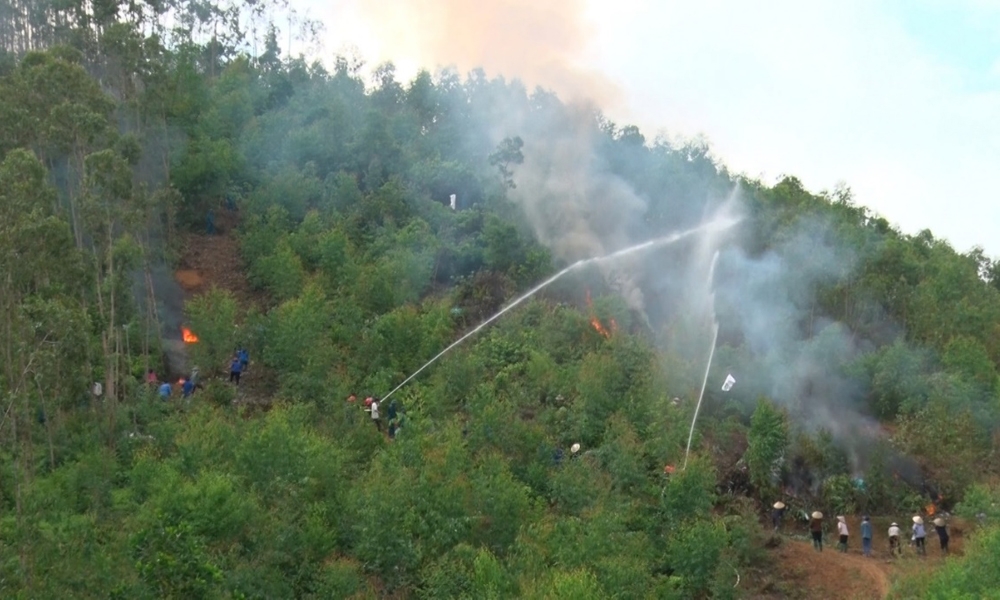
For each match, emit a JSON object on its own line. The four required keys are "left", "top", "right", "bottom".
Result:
{"left": 0, "top": 0, "right": 1000, "bottom": 599}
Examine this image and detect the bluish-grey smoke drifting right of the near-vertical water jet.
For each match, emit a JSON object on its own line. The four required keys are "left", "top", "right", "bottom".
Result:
{"left": 717, "top": 219, "right": 879, "bottom": 474}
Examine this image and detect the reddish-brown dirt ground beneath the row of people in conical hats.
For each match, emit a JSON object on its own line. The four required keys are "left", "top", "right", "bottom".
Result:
{"left": 751, "top": 516, "right": 967, "bottom": 600}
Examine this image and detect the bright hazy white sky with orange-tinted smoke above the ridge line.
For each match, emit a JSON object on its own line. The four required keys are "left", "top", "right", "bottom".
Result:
{"left": 291, "top": 0, "right": 1000, "bottom": 257}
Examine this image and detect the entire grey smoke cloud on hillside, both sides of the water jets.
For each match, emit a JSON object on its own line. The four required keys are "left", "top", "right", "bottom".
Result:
{"left": 484, "top": 89, "right": 879, "bottom": 472}
